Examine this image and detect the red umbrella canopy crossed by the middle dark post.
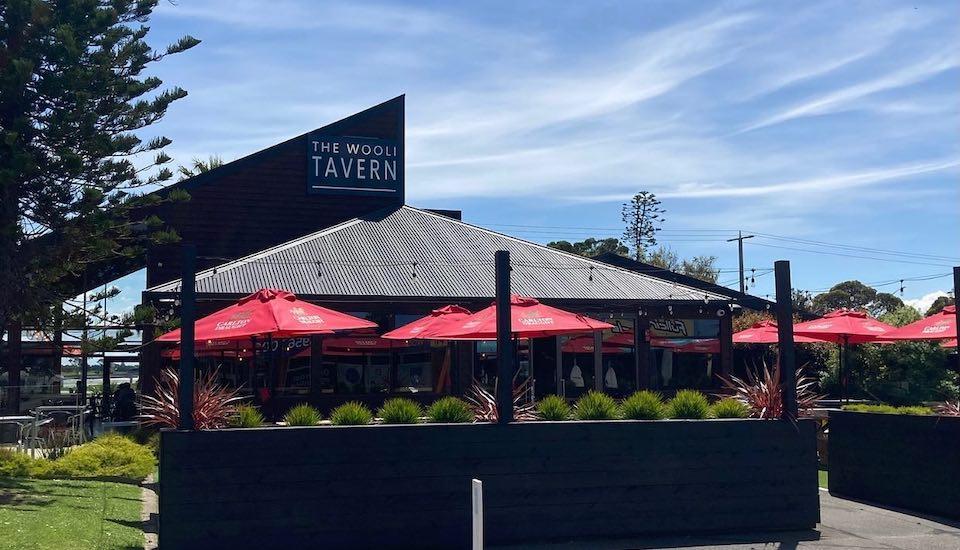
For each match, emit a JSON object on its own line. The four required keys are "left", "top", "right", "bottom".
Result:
{"left": 430, "top": 295, "right": 613, "bottom": 340}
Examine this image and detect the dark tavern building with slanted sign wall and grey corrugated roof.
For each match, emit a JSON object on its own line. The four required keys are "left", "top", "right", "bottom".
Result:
{"left": 0, "top": 96, "right": 769, "bottom": 414}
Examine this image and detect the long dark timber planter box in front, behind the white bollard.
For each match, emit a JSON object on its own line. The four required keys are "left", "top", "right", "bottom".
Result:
{"left": 160, "top": 420, "right": 819, "bottom": 549}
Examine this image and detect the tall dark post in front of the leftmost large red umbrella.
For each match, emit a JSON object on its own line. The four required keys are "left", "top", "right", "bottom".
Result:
{"left": 179, "top": 243, "right": 197, "bottom": 430}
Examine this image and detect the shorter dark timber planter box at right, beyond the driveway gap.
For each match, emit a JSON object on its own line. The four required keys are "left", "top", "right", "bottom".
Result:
{"left": 829, "top": 411, "right": 960, "bottom": 518}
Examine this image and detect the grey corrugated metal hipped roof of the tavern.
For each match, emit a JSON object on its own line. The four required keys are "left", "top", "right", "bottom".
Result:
{"left": 149, "top": 206, "right": 729, "bottom": 301}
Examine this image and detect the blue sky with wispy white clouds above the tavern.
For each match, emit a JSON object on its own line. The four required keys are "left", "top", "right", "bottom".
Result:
{"left": 105, "top": 0, "right": 960, "bottom": 316}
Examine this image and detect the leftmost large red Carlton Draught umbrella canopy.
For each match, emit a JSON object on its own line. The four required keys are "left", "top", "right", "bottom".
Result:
{"left": 158, "top": 288, "right": 377, "bottom": 342}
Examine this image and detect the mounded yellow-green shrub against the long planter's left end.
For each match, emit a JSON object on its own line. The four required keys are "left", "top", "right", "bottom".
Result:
{"left": 42, "top": 434, "right": 156, "bottom": 481}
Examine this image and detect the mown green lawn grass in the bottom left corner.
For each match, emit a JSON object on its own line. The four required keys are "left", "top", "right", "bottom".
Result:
{"left": 0, "top": 478, "right": 143, "bottom": 550}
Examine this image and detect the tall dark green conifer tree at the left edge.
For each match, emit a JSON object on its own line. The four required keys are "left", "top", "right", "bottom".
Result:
{"left": 0, "top": 0, "right": 199, "bottom": 332}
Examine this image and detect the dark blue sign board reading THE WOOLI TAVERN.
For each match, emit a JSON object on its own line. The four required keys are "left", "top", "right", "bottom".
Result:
{"left": 307, "top": 134, "right": 403, "bottom": 196}
